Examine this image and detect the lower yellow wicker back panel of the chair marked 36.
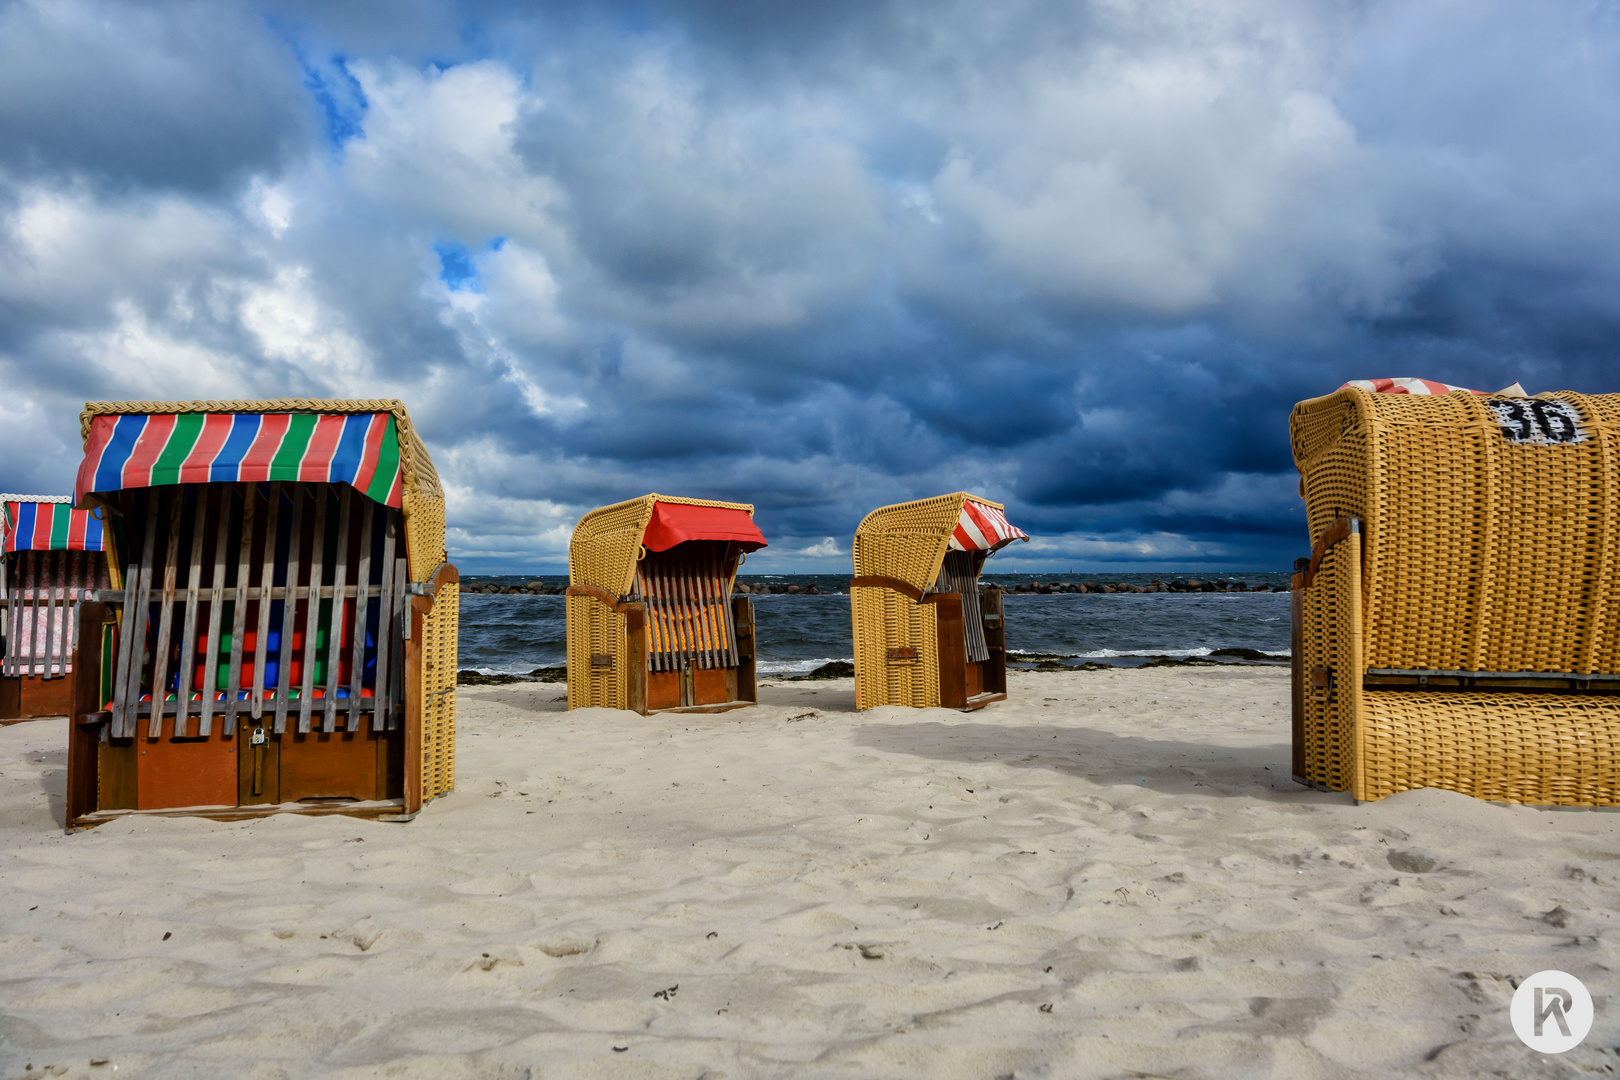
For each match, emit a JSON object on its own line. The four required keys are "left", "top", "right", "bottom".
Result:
{"left": 1359, "top": 690, "right": 1620, "bottom": 806}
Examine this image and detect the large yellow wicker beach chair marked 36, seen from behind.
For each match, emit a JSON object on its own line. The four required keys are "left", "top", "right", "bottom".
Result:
{"left": 1291, "top": 381, "right": 1620, "bottom": 806}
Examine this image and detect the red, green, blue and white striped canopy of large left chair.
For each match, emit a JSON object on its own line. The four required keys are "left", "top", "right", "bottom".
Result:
{"left": 73, "top": 413, "right": 403, "bottom": 507}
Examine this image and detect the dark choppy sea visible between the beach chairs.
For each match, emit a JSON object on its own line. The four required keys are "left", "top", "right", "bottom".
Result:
{"left": 460, "top": 570, "right": 1288, "bottom": 675}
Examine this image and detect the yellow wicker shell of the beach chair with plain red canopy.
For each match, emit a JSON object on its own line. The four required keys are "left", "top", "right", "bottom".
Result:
{"left": 567, "top": 494, "right": 753, "bottom": 709}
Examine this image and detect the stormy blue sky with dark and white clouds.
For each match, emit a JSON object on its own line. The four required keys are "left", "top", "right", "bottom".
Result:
{"left": 0, "top": 0, "right": 1620, "bottom": 573}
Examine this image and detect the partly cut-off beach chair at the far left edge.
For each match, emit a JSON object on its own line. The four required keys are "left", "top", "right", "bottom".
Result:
{"left": 0, "top": 495, "right": 112, "bottom": 721}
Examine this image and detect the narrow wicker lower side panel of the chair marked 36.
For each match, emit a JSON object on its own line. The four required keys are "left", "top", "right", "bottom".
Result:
{"left": 1302, "top": 534, "right": 1362, "bottom": 792}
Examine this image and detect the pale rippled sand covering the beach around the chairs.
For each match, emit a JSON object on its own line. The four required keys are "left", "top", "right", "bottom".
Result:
{"left": 0, "top": 669, "right": 1620, "bottom": 1080}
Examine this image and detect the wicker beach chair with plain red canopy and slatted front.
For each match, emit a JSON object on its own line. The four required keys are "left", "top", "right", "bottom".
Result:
{"left": 567, "top": 495, "right": 765, "bottom": 716}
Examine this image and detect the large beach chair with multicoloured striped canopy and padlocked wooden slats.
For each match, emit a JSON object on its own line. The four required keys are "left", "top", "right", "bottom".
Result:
{"left": 66, "top": 400, "right": 460, "bottom": 829}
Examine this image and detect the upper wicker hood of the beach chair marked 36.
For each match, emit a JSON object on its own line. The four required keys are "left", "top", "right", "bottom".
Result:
{"left": 1293, "top": 390, "right": 1620, "bottom": 674}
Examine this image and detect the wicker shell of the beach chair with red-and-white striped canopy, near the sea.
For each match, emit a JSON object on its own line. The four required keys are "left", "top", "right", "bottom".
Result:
{"left": 849, "top": 491, "right": 1004, "bottom": 709}
